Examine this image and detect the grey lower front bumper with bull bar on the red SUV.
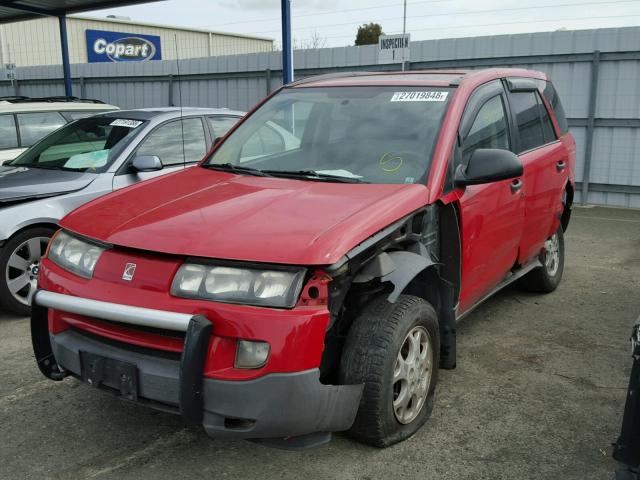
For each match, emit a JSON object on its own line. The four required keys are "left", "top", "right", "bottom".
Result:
{"left": 31, "top": 290, "right": 363, "bottom": 438}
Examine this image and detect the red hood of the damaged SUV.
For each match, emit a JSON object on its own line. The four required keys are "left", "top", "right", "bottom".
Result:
{"left": 61, "top": 167, "right": 428, "bottom": 265}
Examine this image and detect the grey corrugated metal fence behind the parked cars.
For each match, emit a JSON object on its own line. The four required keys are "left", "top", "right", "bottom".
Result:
{"left": 0, "top": 27, "right": 640, "bottom": 208}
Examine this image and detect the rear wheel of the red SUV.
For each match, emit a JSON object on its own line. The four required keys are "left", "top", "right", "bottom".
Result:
{"left": 518, "top": 226, "right": 564, "bottom": 293}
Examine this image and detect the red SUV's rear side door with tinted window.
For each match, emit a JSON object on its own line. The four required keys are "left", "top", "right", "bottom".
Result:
{"left": 507, "top": 79, "right": 568, "bottom": 264}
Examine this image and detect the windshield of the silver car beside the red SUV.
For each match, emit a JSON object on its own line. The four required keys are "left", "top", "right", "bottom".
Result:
{"left": 5, "top": 117, "right": 145, "bottom": 173}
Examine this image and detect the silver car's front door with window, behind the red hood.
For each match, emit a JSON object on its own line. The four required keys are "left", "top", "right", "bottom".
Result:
{"left": 113, "top": 117, "right": 207, "bottom": 190}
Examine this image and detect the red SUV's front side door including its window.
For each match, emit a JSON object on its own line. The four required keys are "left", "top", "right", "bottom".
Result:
{"left": 454, "top": 81, "right": 524, "bottom": 313}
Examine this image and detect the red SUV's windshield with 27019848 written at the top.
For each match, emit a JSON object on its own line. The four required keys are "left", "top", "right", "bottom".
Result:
{"left": 203, "top": 86, "right": 452, "bottom": 183}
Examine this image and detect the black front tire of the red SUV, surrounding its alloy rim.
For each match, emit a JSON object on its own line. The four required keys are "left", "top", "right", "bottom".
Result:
{"left": 340, "top": 295, "right": 440, "bottom": 447}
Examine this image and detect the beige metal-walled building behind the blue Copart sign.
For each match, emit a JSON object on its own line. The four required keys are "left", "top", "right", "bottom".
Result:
{"left": 0, "top": 14, "right": 273, "bottom": 67}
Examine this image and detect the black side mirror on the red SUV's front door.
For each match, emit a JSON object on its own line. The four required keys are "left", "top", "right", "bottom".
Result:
{"left": 454, "top": 148, "right": 523, "bottom": 186}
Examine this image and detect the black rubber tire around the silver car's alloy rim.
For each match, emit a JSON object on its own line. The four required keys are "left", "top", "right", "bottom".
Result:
{"left": 0, "top": 227, "right": 55, "bottom": 316}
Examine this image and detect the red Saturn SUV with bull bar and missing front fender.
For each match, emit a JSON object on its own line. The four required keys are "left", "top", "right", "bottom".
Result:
{"left": 32, "top": 69, "right": 575, "bottom": 446}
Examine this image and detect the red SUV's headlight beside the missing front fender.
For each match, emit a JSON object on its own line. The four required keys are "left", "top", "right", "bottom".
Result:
{"left": 171, "top": 263, "right": 304, "bottom": 308}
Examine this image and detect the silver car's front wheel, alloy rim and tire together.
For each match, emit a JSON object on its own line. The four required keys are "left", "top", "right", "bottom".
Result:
{"left": 0, "top": 227, "right": 55, "bottom": 315}
